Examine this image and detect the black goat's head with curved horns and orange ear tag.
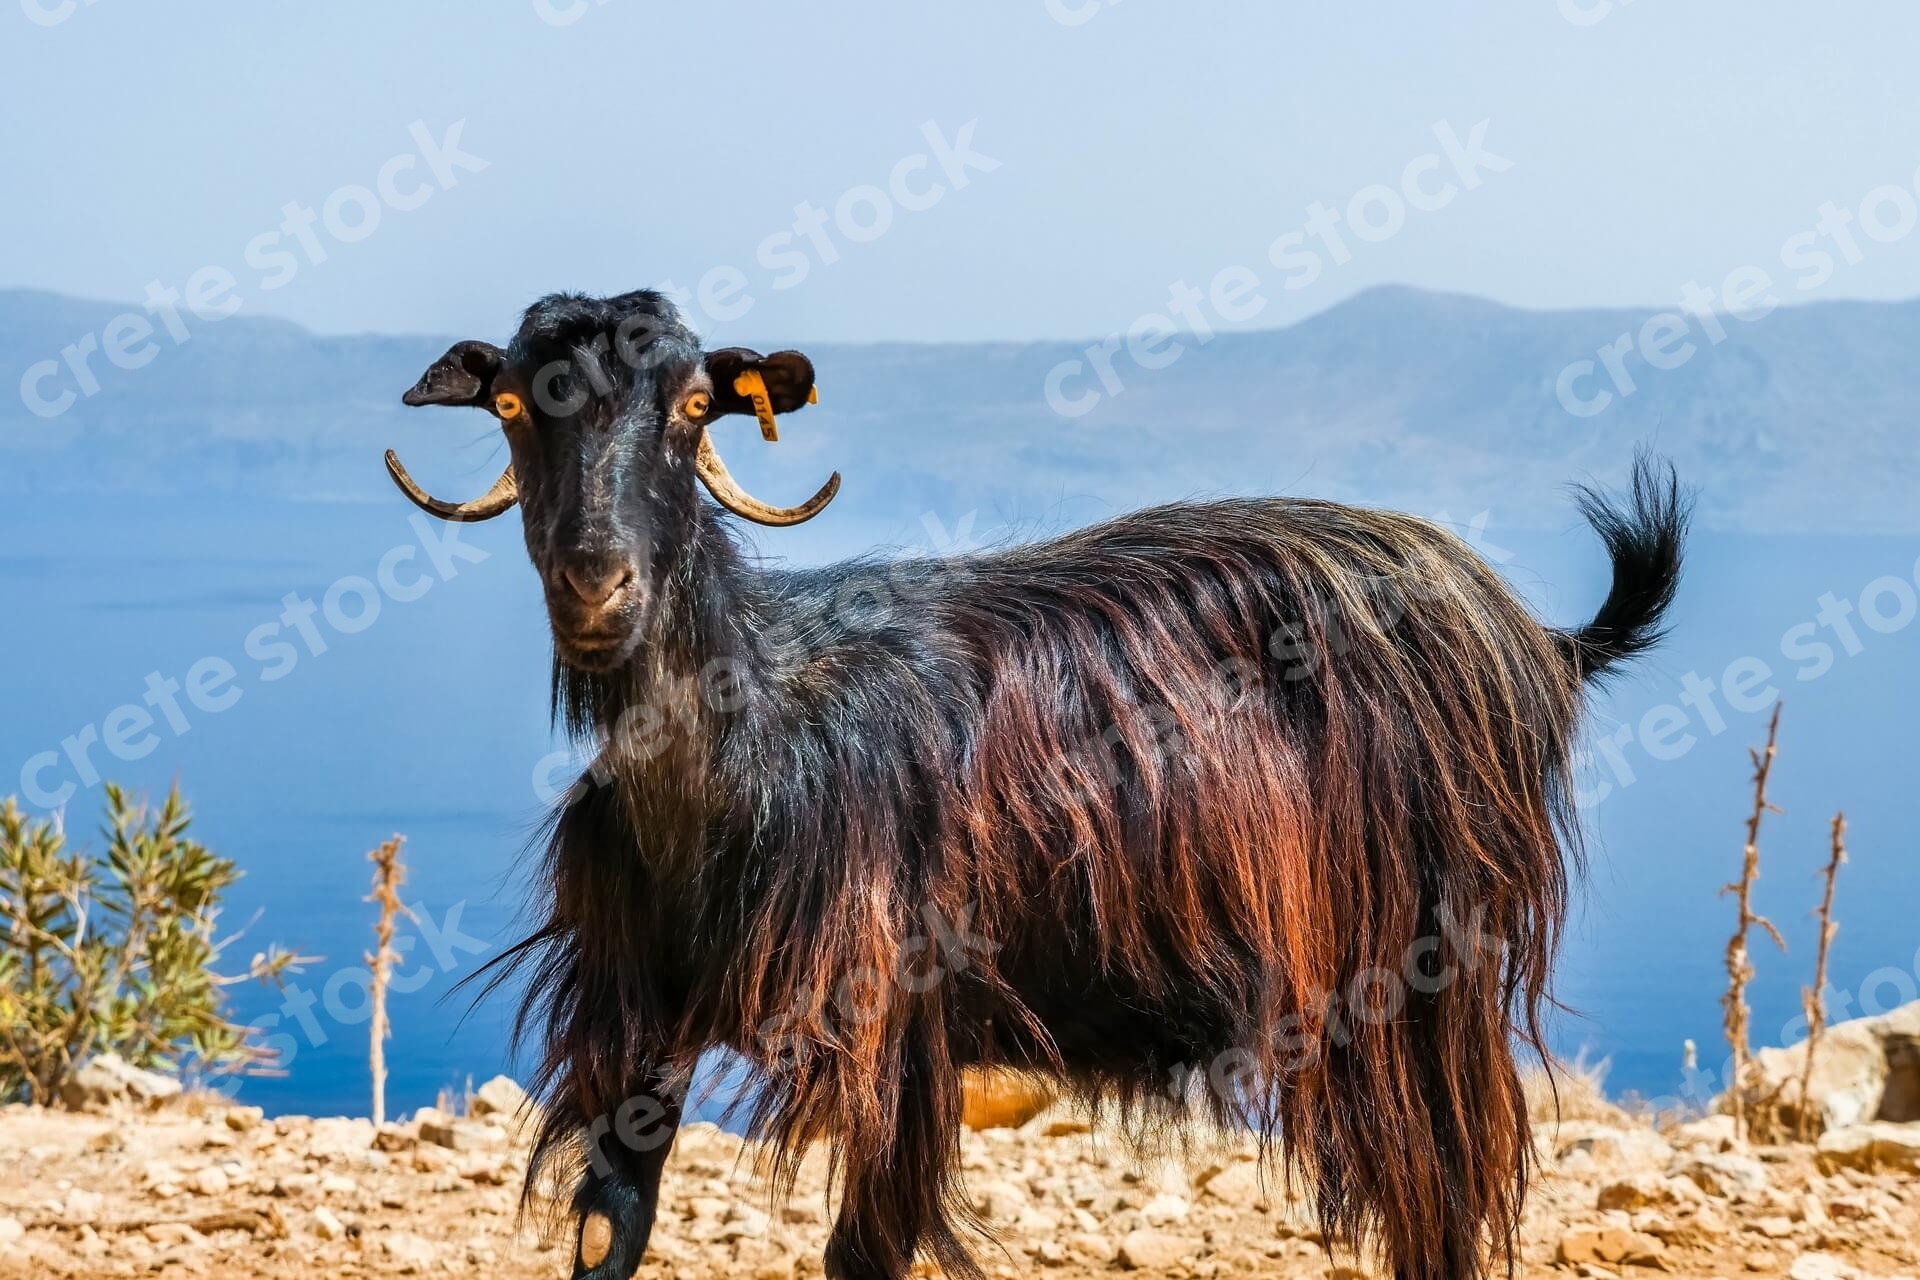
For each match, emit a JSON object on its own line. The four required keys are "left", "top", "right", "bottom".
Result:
{"left": 386, "top": 292, "right": 839, "bottom": 672}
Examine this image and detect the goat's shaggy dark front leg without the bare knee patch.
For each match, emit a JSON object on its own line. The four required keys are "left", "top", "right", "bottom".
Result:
{"left": 826, "top": 1036, "right": 981, "bottom": 1280}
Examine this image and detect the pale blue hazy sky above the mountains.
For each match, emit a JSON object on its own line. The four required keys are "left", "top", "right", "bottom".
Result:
{"left": 0, "top": 0, "right": 1920, "bottom": 342}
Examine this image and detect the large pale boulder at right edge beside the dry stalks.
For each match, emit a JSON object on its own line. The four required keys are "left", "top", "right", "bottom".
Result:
{"left": 1743, "top": 1002, "right": 1920, "bottom": 1132}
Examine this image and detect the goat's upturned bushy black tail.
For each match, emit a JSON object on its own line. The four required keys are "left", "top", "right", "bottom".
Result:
{"left": 1553, "top": 453, "right": 1692, "bottom": 679}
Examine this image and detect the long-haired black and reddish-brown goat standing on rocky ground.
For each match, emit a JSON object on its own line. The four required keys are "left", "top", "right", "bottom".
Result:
{"left": 388, "top": 292, "right": 1686, "bottom": 1280}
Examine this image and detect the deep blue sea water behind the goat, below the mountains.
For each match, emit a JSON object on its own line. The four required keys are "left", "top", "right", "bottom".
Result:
{"left": 0, "top": 497, "right": 1920, "bottom": 1113}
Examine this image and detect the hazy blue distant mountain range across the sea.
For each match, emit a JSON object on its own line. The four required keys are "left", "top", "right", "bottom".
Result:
{"left": 0, "top": 288, "right": 1920, "bottom": 532}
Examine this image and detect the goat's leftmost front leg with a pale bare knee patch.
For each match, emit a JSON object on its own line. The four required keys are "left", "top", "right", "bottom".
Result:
{"left": 574, "top": 1082, "right": 680, "bottom": 1280}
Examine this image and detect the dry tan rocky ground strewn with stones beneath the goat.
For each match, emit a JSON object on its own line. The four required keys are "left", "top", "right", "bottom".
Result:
{"left": 0, "top": 1080, "right": 1920, "bottom": 1280}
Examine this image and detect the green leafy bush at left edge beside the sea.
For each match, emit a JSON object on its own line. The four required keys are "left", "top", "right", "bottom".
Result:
{"left": 0, "top": 783, "right": 309, "bottom": 1103}
